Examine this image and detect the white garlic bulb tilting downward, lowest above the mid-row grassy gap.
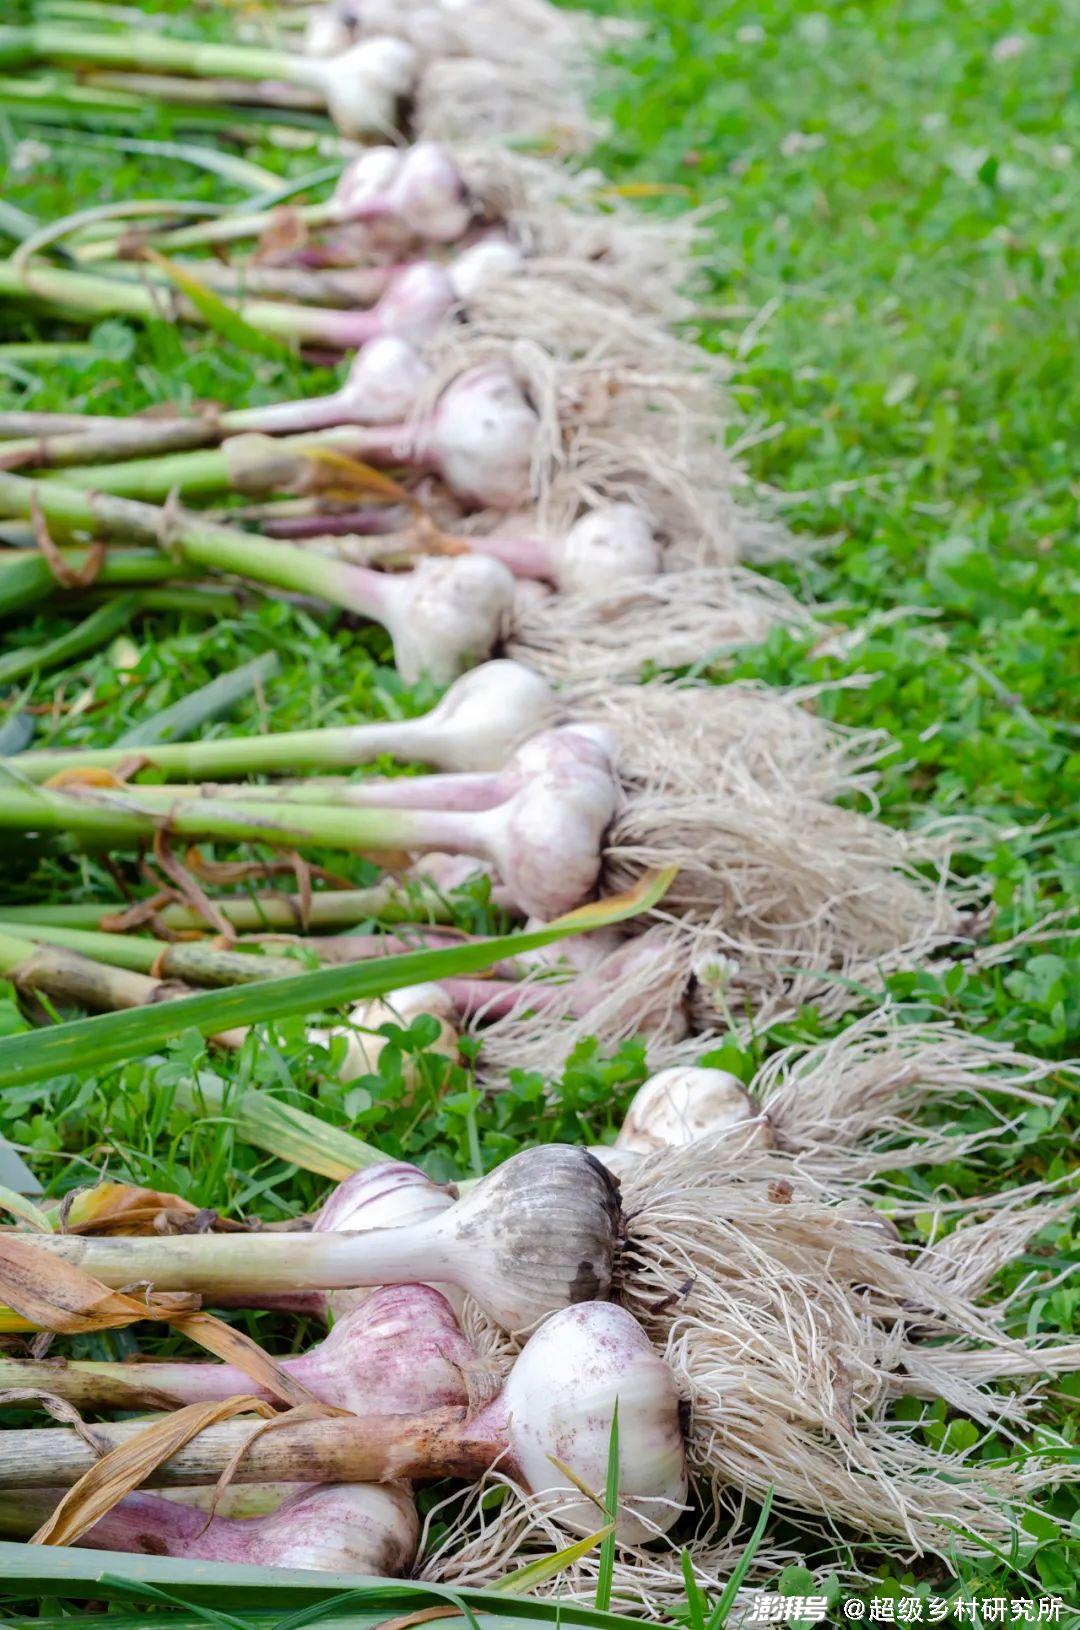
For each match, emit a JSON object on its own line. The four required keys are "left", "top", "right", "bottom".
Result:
{"left": 383, "top": 554, "right": 513, "bottom": 685}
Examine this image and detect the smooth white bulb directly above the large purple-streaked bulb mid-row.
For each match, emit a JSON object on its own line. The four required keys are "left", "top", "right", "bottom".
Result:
{"left": 395, "top": 657, "right": 555, "bottom": 769}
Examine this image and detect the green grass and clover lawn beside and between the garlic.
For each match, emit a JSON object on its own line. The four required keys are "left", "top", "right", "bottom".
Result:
{"left": 0, "top": 0, "right": 1080, "bottom": 1615}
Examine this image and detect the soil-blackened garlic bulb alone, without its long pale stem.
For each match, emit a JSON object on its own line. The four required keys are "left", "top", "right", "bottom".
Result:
{"left": 425, "top": 1143, "right": 622, "bottom": 1333}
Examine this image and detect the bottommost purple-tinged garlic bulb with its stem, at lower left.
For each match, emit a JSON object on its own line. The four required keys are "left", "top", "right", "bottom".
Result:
{"left": 0, "top": 1483, "right": 420, "bottom": 1578}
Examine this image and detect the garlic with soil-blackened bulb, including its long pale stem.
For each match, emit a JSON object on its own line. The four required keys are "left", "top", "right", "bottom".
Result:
{"left": 34, "top": 1144, "right": 622, "bottom": 1333}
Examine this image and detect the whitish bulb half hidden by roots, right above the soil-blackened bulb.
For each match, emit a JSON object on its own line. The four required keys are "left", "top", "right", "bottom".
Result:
{"left": 616, "top": 1064, "right": 772, "bottom": 1154}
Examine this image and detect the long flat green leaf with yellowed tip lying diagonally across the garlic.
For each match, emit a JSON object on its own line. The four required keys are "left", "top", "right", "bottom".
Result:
{"left": 0, "top": 872, "right": 673, "bottom": 1087}
